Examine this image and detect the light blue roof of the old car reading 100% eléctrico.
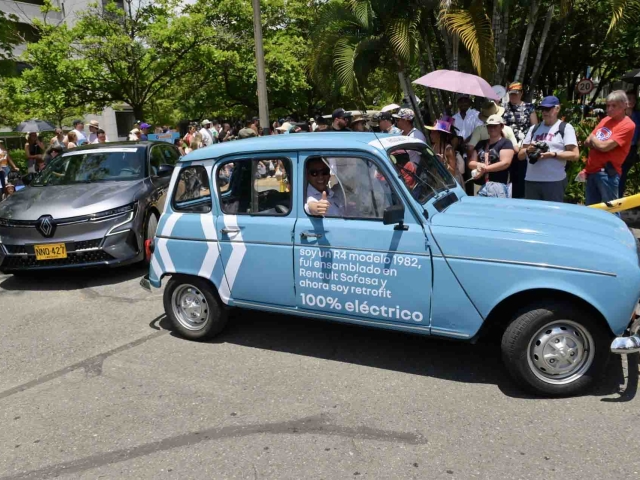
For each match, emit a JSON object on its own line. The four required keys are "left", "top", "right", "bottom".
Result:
{"left": 180, "top": 132, "right": 416, "bottom": 162}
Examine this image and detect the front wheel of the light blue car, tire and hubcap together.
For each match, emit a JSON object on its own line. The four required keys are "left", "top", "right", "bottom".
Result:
{"left": 502, "top": 302, "right": 612, "bottom": 397}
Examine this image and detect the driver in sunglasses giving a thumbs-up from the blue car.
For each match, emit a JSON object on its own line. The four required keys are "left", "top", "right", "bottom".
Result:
{"left": 304, "top": 158, "right": 344, "bottom": 217}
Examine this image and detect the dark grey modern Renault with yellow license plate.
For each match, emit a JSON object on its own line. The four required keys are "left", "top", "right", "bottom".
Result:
{"left": 0, "top": 142, "right": 180, "bottom": 273}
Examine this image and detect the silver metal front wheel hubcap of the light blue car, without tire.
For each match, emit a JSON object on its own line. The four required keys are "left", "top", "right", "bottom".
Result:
{"left": 528, "top": 320, "right": 595, "bottom": 385}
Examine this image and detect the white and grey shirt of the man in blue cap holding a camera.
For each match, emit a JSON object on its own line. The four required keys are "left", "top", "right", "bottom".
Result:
{"left": 523, "top": 120, "right": 578, "bottom": 182}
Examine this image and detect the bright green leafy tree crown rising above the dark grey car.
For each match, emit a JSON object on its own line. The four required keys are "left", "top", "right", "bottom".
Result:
{"left": 74, "top": 0, "right": 213, "bottom": 118}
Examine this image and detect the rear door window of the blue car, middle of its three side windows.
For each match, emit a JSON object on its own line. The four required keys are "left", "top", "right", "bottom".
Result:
{"left": 216, "top": 158, "right": 293, "bottom": 216}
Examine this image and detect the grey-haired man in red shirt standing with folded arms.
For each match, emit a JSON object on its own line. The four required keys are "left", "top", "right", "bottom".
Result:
{"left": 584, "top": 90, "right": 636, "bottom": 205}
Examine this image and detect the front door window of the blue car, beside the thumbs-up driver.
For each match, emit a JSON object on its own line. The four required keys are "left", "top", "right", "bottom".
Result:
{"left": 304, "top": 157, "right": 401, "bottom": 220}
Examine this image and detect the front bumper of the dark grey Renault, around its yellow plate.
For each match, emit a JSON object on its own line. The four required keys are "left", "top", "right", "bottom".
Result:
{"left": 0, "top": 215, "right": 144, "bottom": 273}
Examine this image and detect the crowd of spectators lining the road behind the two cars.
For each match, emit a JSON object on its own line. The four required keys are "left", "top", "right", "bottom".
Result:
{"left": 0, "top": 82, "right": 640, "bottom": 205}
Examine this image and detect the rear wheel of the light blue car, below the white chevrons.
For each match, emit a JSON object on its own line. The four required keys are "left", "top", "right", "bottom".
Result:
{"left": 163, "top": 275, "right": 228, "bottom": 340}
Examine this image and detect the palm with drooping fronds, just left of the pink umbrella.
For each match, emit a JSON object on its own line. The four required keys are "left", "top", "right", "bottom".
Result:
{"left": 311, "top": 0, "right": 423, "bottom": 127}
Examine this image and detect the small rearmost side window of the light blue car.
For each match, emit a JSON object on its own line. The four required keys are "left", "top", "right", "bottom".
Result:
{"left": 171, "top": 165, "right": 211, "bottom": 213}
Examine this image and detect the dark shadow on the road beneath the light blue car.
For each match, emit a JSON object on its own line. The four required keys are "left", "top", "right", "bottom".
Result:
{"left": 154, "top": 311, "right": 637, "bottom": 401}
